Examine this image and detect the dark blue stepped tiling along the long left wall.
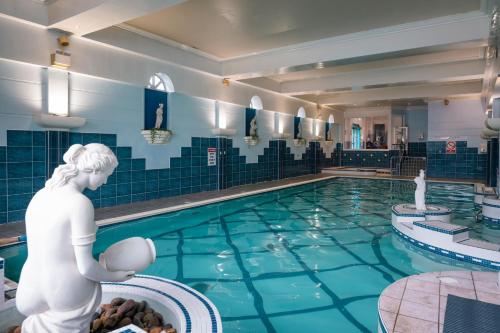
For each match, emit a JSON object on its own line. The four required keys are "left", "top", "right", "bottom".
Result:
{"left": 0, "top": 130, "right": 331, "bottom": 223}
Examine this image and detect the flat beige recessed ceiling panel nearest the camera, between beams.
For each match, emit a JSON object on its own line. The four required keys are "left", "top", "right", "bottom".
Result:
{"left": 127, "top": 0, "right": 481, "bottom": 58}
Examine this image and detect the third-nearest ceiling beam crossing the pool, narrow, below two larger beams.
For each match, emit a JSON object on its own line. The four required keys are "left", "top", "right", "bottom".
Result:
{"left": 318, "top": 81, "right": 482, "bottom": 105}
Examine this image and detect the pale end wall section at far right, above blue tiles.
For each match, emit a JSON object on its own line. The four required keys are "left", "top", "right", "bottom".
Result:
{"left": 428, "top": 99, "right": 486, "bottom": 147}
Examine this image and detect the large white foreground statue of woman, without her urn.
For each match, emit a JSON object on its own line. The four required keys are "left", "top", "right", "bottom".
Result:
{"left": 16, "top": 143, "right": 134, "bottom": 333}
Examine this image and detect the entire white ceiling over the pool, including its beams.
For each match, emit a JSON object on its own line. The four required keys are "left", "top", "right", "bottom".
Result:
{"left": 0, "top": 0, "right": 490, "bottom": 106}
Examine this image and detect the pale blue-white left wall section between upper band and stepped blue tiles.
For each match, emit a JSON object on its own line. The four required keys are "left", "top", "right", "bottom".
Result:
{"left": 0, "top": 59, "right": 340, "bottom": 169}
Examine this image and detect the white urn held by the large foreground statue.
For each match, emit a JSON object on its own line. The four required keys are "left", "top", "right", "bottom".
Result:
{"left": 99, "top": 237, "right": 156, "bottom": 272}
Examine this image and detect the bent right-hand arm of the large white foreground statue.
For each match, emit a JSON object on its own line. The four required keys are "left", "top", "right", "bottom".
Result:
{"left": 71, "top": 197, "right": 134, "bottom": 281}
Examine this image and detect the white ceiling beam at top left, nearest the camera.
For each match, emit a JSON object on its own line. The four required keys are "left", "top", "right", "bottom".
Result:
{"left": 49, "top": 0, "right": 186, "bottom": 36}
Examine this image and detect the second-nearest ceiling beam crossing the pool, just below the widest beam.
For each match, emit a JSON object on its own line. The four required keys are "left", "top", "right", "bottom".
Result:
{"left": 281, "top": 60, "right": 484, "bottom": 95}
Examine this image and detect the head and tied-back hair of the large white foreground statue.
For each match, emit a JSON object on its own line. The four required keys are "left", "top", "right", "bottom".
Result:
{"left": 45, "top": 143, "right": 118, "bottom": 190}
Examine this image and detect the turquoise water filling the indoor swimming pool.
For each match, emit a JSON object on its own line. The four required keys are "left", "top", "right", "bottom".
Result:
{"left": 0, "top": 178, "right": 497, "bottom": 333}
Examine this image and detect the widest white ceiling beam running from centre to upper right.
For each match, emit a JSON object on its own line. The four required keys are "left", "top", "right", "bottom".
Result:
{"left": 222, "top": 11, "right": 489, "bottom": 79}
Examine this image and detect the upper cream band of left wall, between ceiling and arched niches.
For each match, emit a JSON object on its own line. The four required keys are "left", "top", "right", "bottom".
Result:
{"left": 0, "top": 16, "right": 342, "bottom": 120}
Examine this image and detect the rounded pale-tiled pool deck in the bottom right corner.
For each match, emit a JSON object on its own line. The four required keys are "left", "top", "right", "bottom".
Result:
{"left": 378, "top": 271, "right": 500, "bottom": 333}
